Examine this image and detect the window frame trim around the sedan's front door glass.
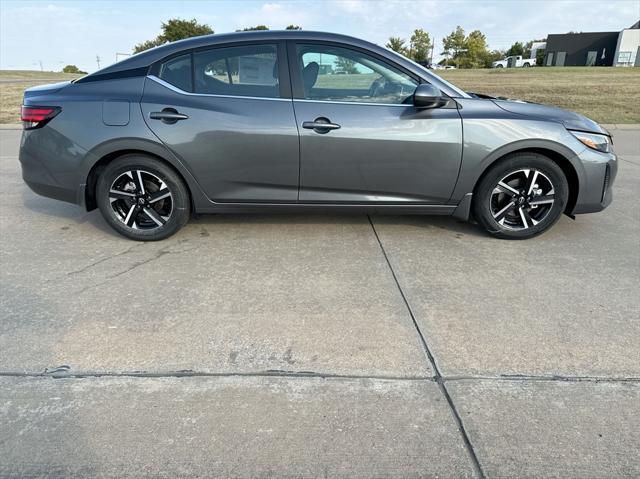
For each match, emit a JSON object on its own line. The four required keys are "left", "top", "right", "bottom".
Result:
{"left": 287, "top": 39, "right": 436, "bottom": 108}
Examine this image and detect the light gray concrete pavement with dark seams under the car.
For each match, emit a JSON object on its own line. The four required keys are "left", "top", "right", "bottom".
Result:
{"left": 0, "top": 130, "right": 640, "bottom": 478}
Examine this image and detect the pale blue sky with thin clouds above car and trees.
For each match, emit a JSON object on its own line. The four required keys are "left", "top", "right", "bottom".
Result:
{"left": 0, "top": 0, "right": 640, "bottom": 72}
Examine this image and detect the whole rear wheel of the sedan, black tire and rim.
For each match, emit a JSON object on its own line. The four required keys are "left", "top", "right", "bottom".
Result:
{"left": 96, "top": 154, "right": 191, "bottom": 241}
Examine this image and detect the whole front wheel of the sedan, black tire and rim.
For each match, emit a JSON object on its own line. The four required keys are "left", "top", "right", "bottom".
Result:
{"left": 473, "top": 152, "right": 569, "bottom": 239}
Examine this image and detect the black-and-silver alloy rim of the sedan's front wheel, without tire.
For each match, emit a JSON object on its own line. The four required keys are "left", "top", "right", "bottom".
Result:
{"left": 490, "top": 169, "right": 555, "bottom": 231}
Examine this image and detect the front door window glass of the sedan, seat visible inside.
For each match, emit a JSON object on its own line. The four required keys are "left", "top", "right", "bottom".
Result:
{"left": 297, "top": 44, "right": 418, "bottom": 104}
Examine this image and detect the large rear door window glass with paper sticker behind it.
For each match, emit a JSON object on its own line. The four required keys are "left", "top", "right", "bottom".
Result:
{"left": 193, "top": 45, "right": 280, "bottom": 98}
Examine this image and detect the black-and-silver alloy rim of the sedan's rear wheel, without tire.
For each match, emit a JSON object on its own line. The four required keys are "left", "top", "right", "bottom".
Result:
{"left": 109, "top": 169, "right": 173, "bottom": 230}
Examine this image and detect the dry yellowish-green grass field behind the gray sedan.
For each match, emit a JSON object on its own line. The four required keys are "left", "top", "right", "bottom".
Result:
{"left": 0, "top": 67, "right": 640, "bottom": 123}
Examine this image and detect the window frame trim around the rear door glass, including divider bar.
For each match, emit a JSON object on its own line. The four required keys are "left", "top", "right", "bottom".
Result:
{"left": 147, "top": 40, "right": 292, "bottom": 101}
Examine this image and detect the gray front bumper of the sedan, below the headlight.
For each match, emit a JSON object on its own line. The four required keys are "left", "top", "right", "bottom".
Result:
{"left": 571, "top": 149, "right": 618, "bottom": 215}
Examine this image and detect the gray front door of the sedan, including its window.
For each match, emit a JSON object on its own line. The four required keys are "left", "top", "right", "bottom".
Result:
{"left": 289, "top": 43, "right": 462, "bottom": 204}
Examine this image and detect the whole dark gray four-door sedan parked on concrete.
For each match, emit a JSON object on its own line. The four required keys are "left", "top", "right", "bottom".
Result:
{"left": 19, "top": 31, "right": 617, "bottom": 241}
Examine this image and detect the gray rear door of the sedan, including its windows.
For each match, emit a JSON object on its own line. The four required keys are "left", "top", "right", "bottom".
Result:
{"left": 141, "top": 42, "right": 299, "bottom": 202}
